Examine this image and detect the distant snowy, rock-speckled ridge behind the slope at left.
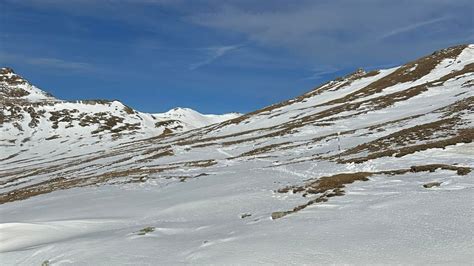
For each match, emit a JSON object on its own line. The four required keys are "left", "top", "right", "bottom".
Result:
{"left": 0, "top": 67, "right": 240, "bottom": 145}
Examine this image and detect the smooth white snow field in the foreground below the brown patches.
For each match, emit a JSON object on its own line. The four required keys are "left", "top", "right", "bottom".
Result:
{"left": 0, "top": 145, "right": 474, "bottom": 265}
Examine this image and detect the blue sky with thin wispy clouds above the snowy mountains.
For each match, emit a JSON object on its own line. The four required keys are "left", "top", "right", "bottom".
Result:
{"left": 0, "top": 0, "right": 474, "bottom": 113}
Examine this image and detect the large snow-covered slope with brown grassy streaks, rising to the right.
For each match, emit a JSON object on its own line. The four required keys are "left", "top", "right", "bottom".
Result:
{"left": 0, "top": 45, "right": 474, "bottom": 264}
